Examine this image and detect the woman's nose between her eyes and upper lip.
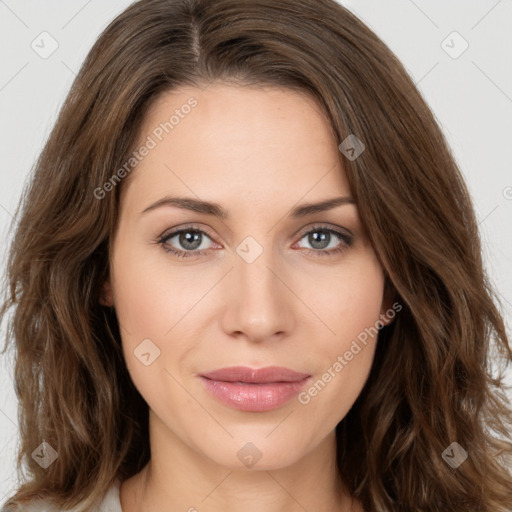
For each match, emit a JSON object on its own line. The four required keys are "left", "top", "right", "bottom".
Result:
{"left": 221, "top": 244, "right": 300, "bottom": 343}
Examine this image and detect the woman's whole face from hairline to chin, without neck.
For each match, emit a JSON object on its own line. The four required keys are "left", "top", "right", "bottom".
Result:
{"left": 106, "top": 83, "right": 387, "bottom": 469}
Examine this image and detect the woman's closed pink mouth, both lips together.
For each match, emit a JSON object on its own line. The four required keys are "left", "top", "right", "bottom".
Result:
{"left": 199, "top": 366, "right": 311, "bottom": 412}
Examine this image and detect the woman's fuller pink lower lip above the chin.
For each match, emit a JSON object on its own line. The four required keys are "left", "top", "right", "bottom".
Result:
{"left": 201, "top": 377, "right": 309, "bottom": 412}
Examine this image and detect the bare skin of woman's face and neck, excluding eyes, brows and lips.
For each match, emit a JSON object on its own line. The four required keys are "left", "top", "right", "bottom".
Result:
{"left": 104, "top": 83, "right": 390, "bottom": 512}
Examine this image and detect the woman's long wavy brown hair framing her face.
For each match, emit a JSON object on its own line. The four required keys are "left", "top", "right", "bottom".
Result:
{"left": 0, "top": 0, "right": 512, "bottom": 512}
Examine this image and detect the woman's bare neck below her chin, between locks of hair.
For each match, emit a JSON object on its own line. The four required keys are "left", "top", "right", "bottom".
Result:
{"left": 120, "top": 412, "right": 362, "bottom": 512}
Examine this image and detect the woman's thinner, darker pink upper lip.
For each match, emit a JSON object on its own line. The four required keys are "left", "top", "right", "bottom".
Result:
{"left": 200, "top": 366, "right": 310, "bottom": 384}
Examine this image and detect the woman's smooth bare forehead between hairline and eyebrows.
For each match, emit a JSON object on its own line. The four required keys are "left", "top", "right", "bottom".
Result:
{"left": 120, "top": 83, "right": 350, "bottom": 211}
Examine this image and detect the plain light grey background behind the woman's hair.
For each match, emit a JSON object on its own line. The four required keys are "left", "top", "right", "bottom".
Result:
{"left": 0, "top": 0, "right": 512, "bottom": 503}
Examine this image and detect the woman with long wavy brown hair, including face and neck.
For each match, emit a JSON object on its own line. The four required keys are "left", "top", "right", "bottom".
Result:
{"left": 2, "top": 0, "right": 512, "bottom": 512}
